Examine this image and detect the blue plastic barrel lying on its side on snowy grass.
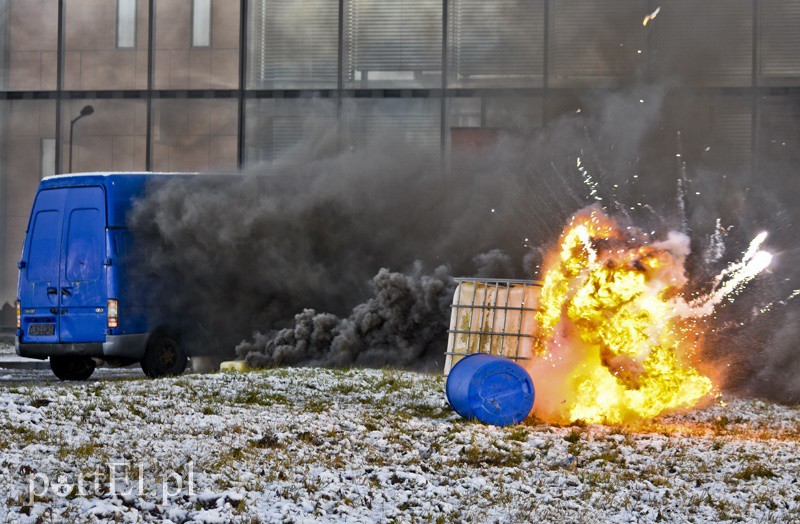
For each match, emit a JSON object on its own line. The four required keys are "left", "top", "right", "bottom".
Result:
{"left": 445, "top": 353, "right": 534, "bottom": 426}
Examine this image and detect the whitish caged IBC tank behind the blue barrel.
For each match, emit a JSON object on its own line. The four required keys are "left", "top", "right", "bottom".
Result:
{"left": 444, "top": 278, "right": 541, "bottom": 377}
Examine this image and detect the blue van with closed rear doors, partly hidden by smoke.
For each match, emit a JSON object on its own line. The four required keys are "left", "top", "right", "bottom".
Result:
{"left": 16, "top": 173, "right": 187, "bottom": 380}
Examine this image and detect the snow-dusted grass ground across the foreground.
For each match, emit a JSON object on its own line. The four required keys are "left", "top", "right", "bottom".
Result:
{"left": 0, "top": 369, "right": 800, "bottom": 523}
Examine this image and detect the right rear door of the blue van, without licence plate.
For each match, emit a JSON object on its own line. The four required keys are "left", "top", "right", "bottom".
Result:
{"left": 59, "top": 186, "right": 108, "bottom": 343}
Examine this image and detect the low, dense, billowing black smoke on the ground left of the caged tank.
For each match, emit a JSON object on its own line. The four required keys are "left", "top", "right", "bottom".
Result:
{"left": 236, "top": 263, "right": 455, "bottom": 369}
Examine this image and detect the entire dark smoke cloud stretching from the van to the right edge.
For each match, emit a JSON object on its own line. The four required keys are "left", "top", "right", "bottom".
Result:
{"left": 126, "top": 2, "right": 800, "bottom": 401}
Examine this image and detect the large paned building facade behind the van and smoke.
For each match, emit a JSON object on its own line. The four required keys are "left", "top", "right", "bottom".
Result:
{"left": 0, "top": 0, "right": 800, "bottom": 323}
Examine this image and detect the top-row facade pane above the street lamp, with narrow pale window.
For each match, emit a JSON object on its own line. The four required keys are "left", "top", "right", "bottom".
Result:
{"left": 65, "top": 0, "right": 147, "bottom": 90}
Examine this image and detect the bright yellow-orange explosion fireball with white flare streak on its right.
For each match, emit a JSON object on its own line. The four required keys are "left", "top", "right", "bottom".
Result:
{"left": 529, "top": 207, "right": 772, "bottom": 423}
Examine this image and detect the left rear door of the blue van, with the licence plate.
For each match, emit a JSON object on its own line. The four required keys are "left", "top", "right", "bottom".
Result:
{"left": 19, "top": 189, "right": 67, "bottom": 344}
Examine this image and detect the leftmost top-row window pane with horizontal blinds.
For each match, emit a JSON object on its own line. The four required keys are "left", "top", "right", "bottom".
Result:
{"left": 248, "top": 0, "right": 339, "bottom": 89}
